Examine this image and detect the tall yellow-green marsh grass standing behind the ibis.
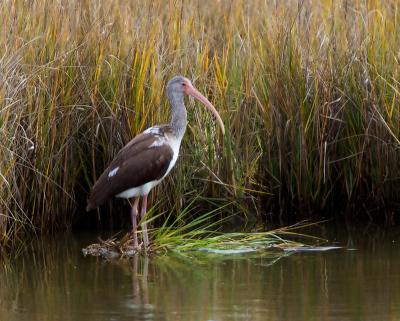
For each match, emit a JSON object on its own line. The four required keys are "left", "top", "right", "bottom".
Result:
{"left": 0, "top": 0, "right": 400, "bottom": 242}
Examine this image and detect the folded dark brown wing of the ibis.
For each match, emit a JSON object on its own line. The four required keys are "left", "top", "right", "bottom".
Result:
{"left": 86, "top": 133, "right": 173, "bottom": 211}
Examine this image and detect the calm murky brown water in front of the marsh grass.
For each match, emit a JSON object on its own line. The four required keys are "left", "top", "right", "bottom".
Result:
{"left": 0, "top": 225, "right": 400, "bottom": 321}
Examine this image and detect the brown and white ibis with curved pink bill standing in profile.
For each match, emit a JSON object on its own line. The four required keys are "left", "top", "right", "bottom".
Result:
{"left": 86, "top": 76, "right": 224, "bottom": 249}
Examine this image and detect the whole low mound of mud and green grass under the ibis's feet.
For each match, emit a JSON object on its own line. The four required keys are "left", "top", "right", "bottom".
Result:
{"left": 82, "top": 197, "right": 324, "bottom": 259}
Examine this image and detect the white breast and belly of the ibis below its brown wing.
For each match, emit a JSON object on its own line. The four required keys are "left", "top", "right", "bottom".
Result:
{"left": 116, "top": 132, "right": 182, "bottom": 198}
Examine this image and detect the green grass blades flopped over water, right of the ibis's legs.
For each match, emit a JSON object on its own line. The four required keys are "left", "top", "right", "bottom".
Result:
{"left": 148, "top": 199, "right": 306, "bottom": 254}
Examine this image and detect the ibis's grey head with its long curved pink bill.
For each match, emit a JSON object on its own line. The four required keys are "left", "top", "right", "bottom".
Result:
{"left": 167, "top": 76, "right": 225, "bottom": 134}
